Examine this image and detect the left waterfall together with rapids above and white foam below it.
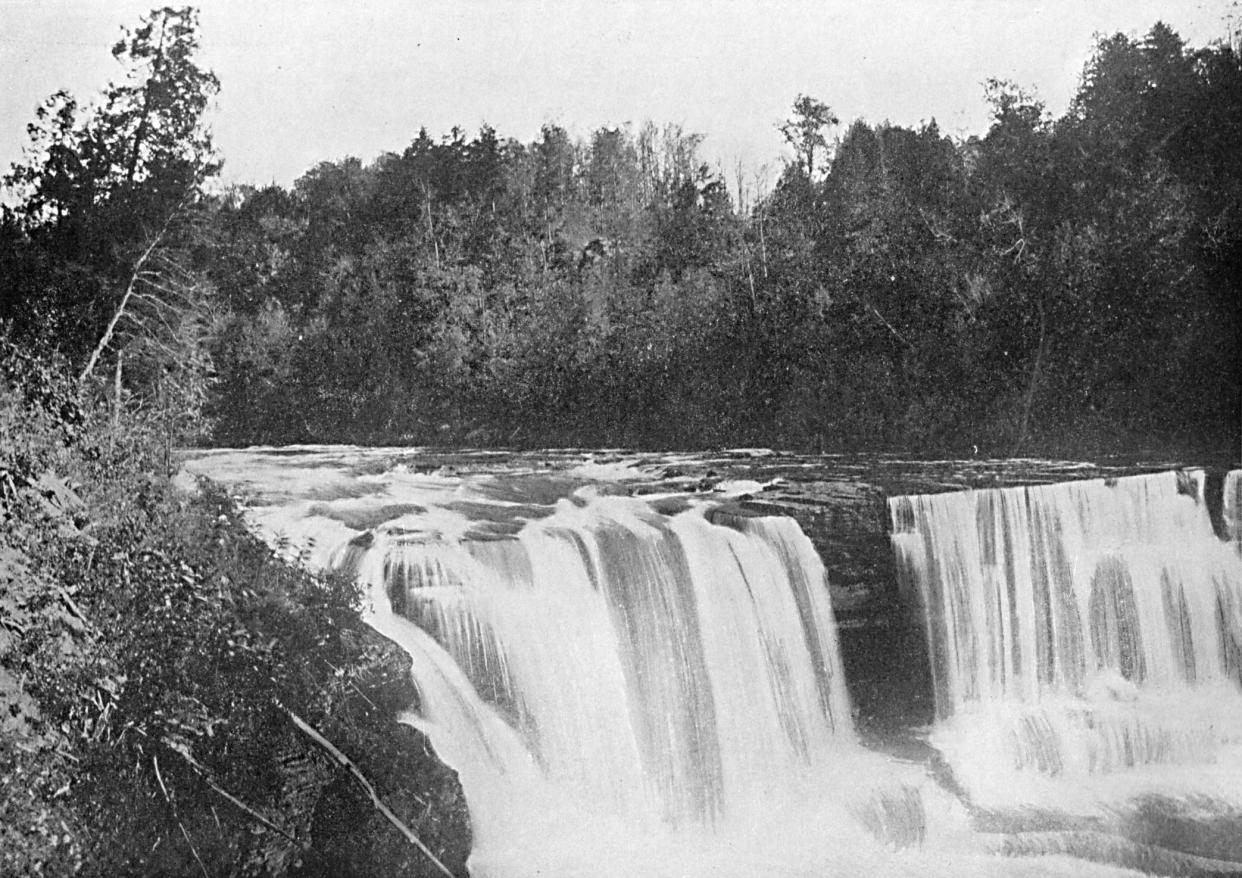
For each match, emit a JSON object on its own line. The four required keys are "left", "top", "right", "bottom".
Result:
{"left": 181, "top": 448, "right": 1192, "bottom": 878}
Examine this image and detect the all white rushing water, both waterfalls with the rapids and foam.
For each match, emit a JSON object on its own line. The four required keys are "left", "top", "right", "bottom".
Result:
{"left": 181, "top": 448, "right": 1222, "bottom": 878}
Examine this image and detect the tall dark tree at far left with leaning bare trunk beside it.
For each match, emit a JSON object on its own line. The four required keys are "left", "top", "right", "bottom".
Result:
{"left": 4, "top": 6, "right": 220, "bottom": 439}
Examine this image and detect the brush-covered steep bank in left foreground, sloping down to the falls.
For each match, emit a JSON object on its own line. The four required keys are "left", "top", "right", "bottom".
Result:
{"left": 0, "top": 340, "right": 469, "bottom": 876}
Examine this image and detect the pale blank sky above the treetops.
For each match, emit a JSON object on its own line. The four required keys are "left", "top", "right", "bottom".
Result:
{"left": 0, "top": 0, "right": 1242, "bottom": 193}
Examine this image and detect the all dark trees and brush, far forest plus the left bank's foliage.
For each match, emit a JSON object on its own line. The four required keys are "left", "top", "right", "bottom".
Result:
{"left": 0, "top": 9, "right": 1242, "bottom": 874}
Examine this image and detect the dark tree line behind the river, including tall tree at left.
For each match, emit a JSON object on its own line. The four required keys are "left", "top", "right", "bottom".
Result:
{"left": 0, "top": 10, "right": 1242, "bottom": 453}
